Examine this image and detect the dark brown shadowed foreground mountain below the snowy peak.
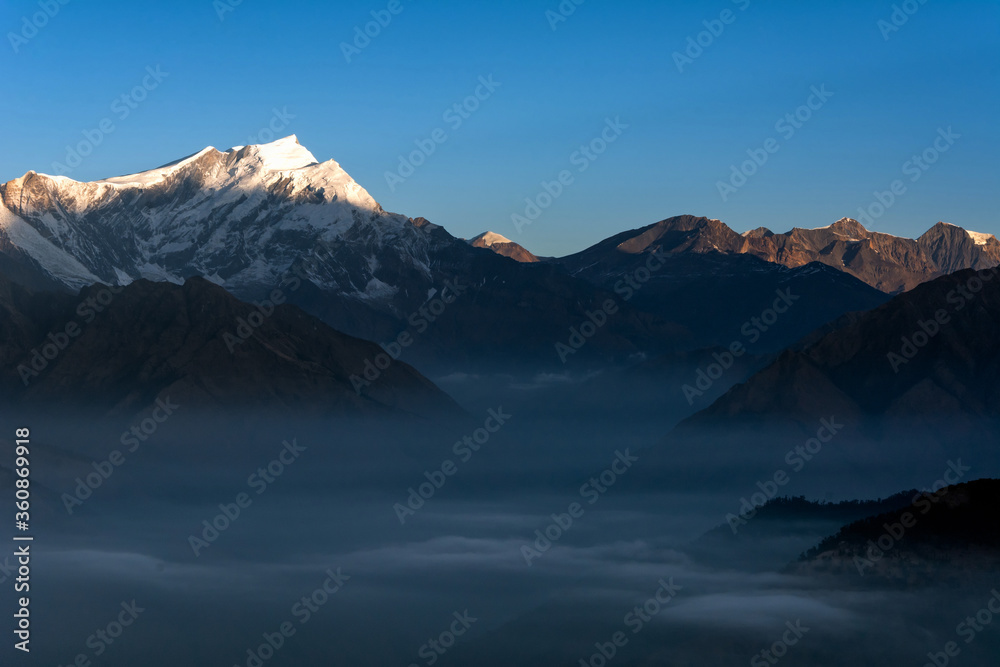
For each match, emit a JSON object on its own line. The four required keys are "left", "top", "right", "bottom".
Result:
{"left": 0, "top": 278, "right": 458, "bottom": 416}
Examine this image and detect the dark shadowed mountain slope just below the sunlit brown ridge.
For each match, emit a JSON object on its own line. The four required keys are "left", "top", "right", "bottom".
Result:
{"left": 551, "top": 224, "right": 888, "bottom": 352}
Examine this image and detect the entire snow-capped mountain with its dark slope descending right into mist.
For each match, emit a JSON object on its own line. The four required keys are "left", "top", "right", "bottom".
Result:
{"left": 0, "top": 137, "right": 685, "bottom": 369}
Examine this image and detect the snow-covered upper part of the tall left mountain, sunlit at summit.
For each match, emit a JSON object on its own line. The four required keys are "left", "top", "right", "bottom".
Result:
{"left": 0, "top": 136, "right": 437, "bottom": 301}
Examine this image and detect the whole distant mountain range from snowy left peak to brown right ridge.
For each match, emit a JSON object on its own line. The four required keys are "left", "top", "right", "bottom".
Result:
{"left": 0, "top": 136, "right": 1000, "bottom": 400}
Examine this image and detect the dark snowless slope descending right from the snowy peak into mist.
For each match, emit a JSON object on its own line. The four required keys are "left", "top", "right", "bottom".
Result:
{"left": 291, "top": 234, "right": 695, "bottom": 374}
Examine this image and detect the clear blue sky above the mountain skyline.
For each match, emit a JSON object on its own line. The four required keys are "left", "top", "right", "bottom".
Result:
{"left": 0, "top": 0, "right": 1000, "bottom": 254}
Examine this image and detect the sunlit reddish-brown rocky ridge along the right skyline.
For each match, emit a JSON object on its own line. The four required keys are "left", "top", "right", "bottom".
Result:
{"left": 564, "top": 215, "right": 1000, "bottom": 293}
